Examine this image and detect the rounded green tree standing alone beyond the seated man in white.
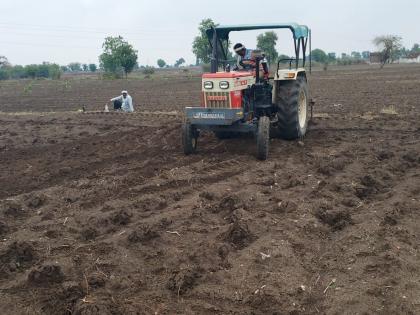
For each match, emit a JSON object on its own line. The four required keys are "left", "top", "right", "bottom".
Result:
{"left": 99, "top": 36, "right": 138, "bottom": 77}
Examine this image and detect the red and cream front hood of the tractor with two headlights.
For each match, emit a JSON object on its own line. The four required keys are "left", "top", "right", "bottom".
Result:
{"left": 201, "top": 71, "right": 255, "bottom": 109}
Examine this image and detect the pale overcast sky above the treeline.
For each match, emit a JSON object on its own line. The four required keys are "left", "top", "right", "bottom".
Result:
{"left": 0, "top": 0, "right": 420, "bottom": 65}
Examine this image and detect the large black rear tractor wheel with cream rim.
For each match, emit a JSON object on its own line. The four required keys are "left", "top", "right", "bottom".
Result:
{"left": 276, "top": 77, "right": 309, "bottom": 140}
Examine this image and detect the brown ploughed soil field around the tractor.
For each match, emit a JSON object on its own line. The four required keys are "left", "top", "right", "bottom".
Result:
{"left": 0, "top": 66, "right": 420, "bottom": 315}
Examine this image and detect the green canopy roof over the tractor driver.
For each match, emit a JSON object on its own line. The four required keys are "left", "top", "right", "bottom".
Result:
{"left": 206, "top": 23, "right": 309, "bottom": 41}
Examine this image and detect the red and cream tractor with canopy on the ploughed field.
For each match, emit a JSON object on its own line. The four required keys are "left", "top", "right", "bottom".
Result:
{"left": 182, "top": 23, "right": 312, "bottom": 160}
